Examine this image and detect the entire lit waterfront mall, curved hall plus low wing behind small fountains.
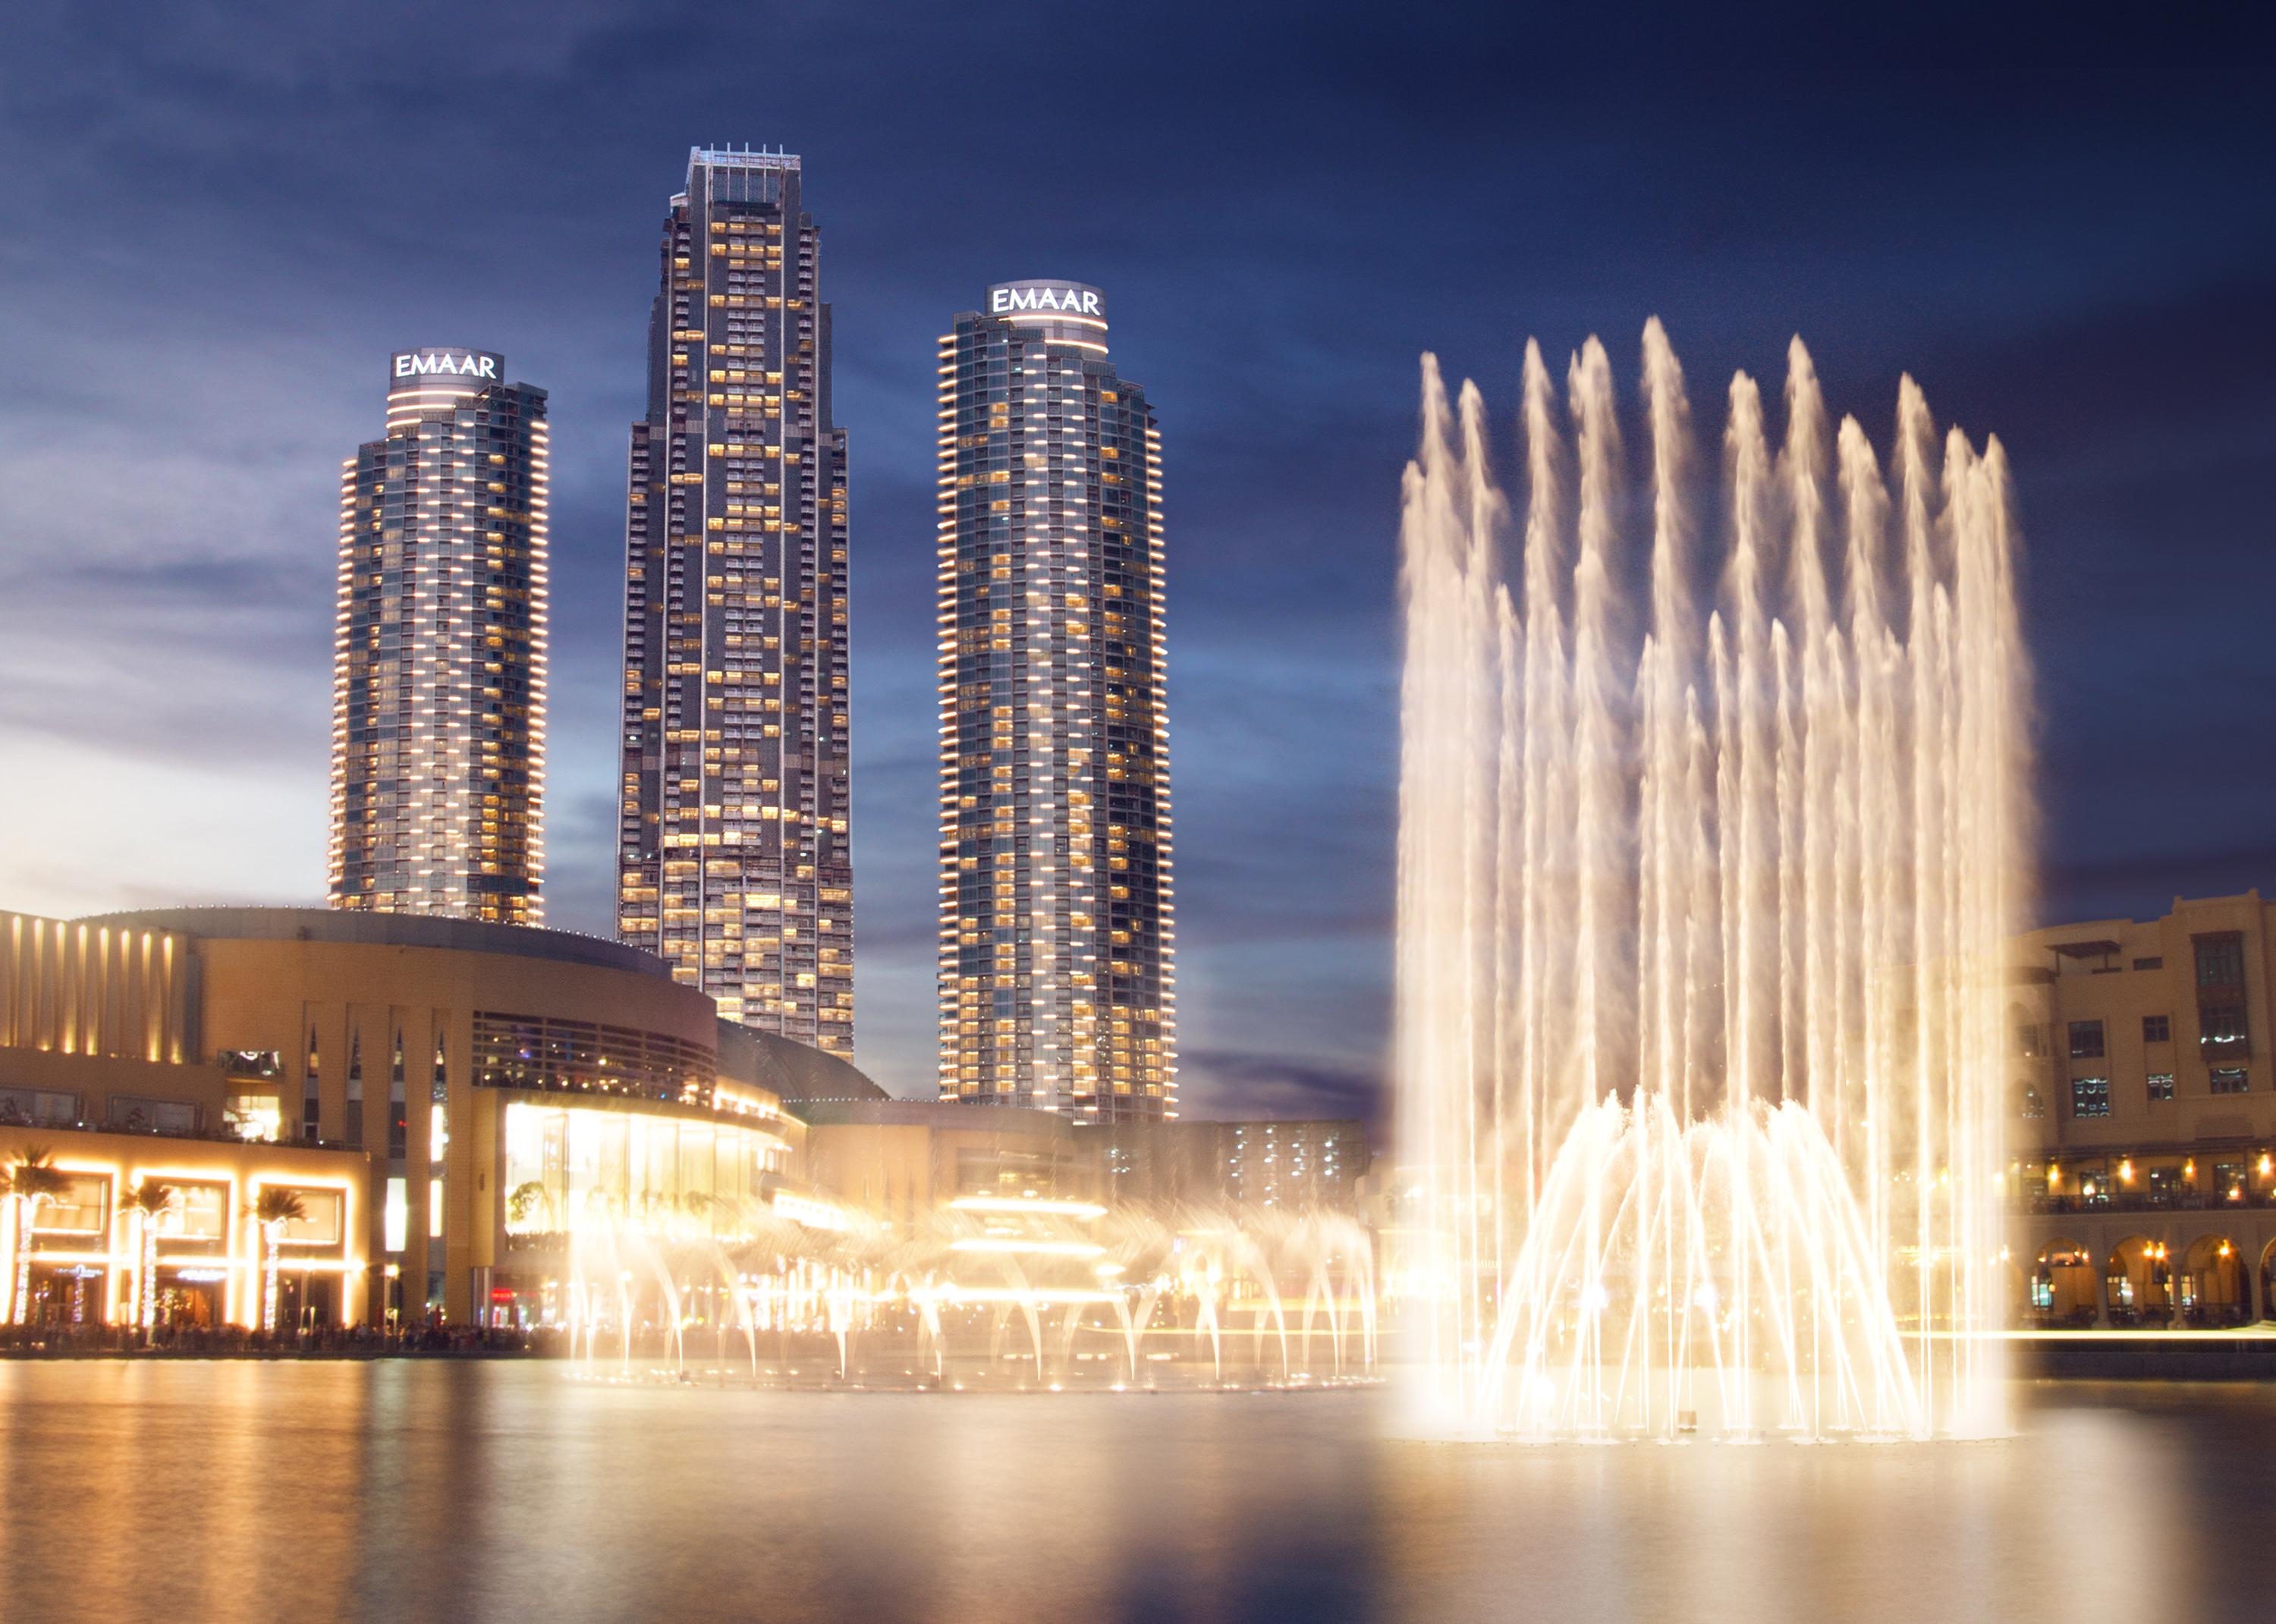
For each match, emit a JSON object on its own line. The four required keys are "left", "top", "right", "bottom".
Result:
{"left": 0, "top": 907, "right": 1366, "bottom": 1328}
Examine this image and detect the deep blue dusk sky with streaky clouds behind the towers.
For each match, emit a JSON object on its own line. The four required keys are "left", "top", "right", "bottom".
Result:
{"left": 0, "top": 0, "right": 2276, "bottom": 1114}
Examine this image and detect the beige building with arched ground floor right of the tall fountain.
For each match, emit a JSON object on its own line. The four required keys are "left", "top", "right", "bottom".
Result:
{"left": 2007, "top": 891, "right": 2276, "bottom": 1328}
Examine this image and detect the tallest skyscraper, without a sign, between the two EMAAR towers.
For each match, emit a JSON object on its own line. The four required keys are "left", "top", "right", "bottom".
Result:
{"left": 617, "top": 148, "right": 854, "bottom": 1055}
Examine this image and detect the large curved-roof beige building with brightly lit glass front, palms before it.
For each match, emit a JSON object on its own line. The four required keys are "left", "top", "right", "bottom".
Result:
{"left": 0, "top": 907, "right": 883, "bottom": 1324}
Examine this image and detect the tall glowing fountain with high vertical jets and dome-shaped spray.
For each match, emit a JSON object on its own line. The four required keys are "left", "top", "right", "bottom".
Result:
{"left": 1393, "top": 321, "right": 2028, "bottom": 1437}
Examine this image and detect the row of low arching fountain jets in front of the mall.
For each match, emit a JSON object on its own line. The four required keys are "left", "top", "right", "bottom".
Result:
{"left": 542, "top": 1194, "right": 1377, "bottom": 1392}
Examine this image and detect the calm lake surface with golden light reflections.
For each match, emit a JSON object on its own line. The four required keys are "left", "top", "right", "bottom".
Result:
{"left": 0, "top": 1360, "right": 2276, "bottom": 1624}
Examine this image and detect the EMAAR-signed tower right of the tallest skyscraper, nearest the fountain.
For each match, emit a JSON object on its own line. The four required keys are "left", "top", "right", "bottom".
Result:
{"left": 938, "top": 282, "right": 1177, "bottom": 1121}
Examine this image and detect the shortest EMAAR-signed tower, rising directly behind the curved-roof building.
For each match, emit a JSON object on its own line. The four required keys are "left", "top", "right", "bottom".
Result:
{"left": 330, "top": 348, "right": 549, "bottom": 925}
